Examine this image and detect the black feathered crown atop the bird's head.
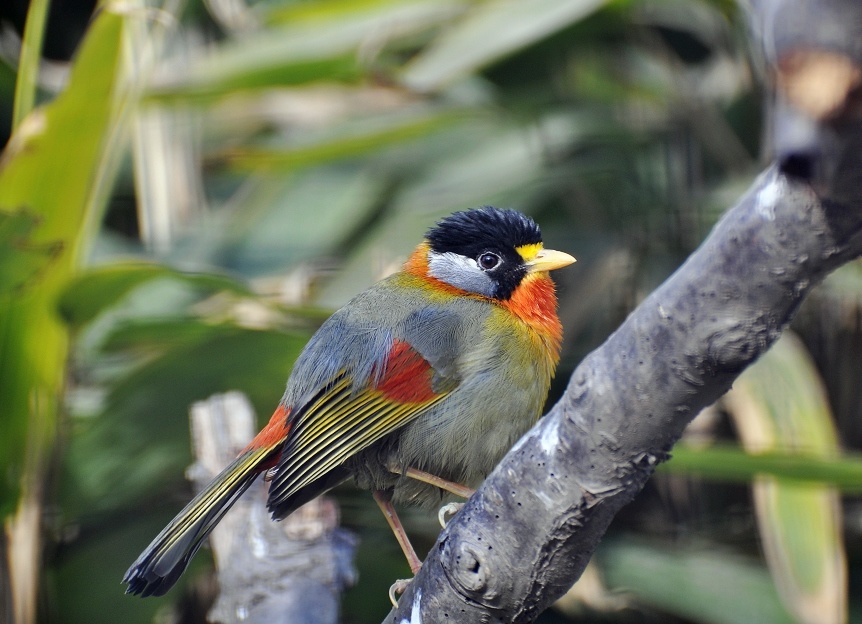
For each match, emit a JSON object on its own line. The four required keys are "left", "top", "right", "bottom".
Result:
{"left": 425, "top": 206, "right": 542, "bottom": 257}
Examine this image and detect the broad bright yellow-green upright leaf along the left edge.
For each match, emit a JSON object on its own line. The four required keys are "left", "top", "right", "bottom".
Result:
{"left": 0, "top": 7, "right": 125, "bottom": 517}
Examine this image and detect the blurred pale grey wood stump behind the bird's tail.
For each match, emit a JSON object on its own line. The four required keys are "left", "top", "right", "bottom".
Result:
{"left": 189, "top": 392, "right": 356, "bottom": 624}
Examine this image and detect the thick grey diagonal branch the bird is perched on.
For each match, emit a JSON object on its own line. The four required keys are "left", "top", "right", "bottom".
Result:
{"left": 386, "top": 0, "right": 862, "bottom": 624}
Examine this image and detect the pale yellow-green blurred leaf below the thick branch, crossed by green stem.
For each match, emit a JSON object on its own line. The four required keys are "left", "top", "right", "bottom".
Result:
{"left": 726, "top": 333, "right": 847, "bottom": 621}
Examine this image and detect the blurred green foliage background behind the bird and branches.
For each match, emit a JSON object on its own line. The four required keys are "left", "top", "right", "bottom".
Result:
{"left": 0, "top": 0, "right": 862, "bottom": 624}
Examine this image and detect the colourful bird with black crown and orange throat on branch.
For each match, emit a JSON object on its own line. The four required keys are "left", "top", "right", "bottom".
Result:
{"left": 123, "top": 206, "right": 575, "bottom": 596}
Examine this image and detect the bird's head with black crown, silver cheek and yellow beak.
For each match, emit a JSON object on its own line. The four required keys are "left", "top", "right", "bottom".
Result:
{"left": 408, "top": 206, "right": 575, "bottom": 301}
